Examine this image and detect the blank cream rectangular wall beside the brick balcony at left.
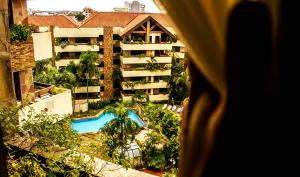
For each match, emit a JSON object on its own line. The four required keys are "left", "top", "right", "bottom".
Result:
{"left": 32, "top": 32, "right": 52, "bottom": 61}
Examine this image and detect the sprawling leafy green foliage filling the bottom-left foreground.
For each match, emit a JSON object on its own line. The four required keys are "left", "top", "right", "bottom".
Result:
{"left": 0, "top": 106, "right": 93, "bottom": 176}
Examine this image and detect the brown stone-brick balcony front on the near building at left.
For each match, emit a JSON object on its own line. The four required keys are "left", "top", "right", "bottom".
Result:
{"left": 11, "top": 38, "right": 35, "bottom": 71}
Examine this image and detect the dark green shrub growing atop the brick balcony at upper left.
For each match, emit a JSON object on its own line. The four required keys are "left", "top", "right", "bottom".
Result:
{"left": 10, "top": 25, "right": 32, "bottom": 42}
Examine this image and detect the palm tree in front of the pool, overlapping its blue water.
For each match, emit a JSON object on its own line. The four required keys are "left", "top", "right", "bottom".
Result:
{"left": 101, "top": 102, "right": 140, "bottom": 158}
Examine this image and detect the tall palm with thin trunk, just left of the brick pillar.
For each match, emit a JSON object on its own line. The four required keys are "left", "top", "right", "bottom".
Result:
{"left": 79, "top": 51, "right": 100, "bottom": 103}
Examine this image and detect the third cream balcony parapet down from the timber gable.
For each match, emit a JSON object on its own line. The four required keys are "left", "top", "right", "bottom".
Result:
{"left": 121, "top": 69, "right": 171, "bottom": 77}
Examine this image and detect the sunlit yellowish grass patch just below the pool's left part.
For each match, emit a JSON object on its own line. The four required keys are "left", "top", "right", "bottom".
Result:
{"left": 80, "top": 133, "right": 111, "bottom": 161}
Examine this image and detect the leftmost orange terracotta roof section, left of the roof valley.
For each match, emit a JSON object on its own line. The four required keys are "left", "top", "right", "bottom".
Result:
{"left": 28, "top": 15, "right": 78, "bottom": 28}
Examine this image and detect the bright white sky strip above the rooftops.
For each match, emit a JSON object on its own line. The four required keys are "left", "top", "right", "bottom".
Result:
{"left": 27, "top": 0, "right": 160, "bottom": 13}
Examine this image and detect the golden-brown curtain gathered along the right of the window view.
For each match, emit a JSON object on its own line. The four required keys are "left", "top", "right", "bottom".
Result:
{"left": 155, "top": 0, "right": 279, "bottom": 177}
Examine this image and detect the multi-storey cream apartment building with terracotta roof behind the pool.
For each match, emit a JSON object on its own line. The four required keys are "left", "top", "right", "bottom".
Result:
{"left": 28, "top": 12, "right": 185, "bottom": 104}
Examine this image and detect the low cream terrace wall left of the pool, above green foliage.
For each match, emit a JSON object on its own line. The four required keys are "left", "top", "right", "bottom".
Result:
{"left": 19, "top": 90, "right": 73, "bottom": 124}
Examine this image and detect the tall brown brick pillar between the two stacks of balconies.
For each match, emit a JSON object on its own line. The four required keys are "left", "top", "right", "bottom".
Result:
{"left": 103, "top": 27, "right": 114, "bottom": 100}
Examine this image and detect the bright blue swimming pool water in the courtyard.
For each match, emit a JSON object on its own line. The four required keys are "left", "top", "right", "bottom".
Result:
{"left": 72, "top": 111, "right": 144, "bottom": 133}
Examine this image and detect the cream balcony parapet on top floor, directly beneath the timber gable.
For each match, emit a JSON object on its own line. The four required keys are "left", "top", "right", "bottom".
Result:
{"left": 120, "top": 42, "right": 172, "bottom": 50}
